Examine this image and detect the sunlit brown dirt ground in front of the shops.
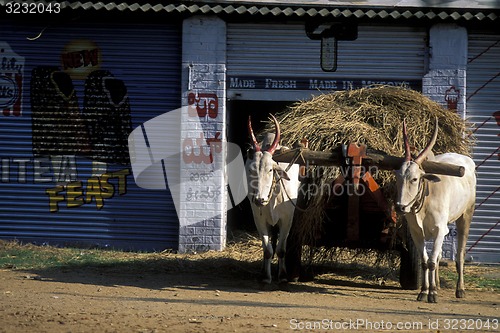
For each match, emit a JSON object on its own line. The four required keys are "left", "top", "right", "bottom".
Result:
{"left": 0, "top": 240, "right": 500, "bottom": 333}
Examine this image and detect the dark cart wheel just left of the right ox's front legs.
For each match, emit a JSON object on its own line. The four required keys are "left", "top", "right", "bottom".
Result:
{"left": 399, "top": 223, "right": 422, "bottom": 290}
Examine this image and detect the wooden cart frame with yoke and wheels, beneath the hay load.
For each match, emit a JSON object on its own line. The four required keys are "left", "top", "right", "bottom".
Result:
{"left": 274, "top": 140, "right": 464, "bottom": 289}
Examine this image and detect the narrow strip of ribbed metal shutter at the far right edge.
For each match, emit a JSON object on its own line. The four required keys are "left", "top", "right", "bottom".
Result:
{"left": 467, "top": 32, "right": 500, "bottom": 263}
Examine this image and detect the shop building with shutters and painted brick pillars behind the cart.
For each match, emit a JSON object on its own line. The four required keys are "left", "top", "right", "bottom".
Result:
{"left": 0, "top": 1, "right": 500, "bottom": 262}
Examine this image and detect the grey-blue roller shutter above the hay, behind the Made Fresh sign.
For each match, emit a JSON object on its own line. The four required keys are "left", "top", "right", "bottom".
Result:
{"left": 227, "top": 23, "right": 427, "bottom": 100}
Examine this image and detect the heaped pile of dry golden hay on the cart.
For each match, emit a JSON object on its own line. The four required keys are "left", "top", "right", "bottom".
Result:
{"left": 263, "top": 86, "right": 473, "bottom": 249}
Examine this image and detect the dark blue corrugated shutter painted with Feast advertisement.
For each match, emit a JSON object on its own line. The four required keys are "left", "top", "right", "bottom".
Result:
{"left": 0, "top": 22, "right": 181, "bottom": 251}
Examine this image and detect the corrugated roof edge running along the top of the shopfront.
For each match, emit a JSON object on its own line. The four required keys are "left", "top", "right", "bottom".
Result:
{"left": 49, "top": 0, "right": 500, "bottom": 21}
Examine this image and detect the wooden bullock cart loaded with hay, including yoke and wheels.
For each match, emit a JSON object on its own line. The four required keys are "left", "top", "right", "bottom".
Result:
{"left": 256, "top": 86, "right": 474, "bottom": 289}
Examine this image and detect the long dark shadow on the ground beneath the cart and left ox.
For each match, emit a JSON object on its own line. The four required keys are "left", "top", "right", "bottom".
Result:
{"left": 16, "top": 250, "right": 406, "bottom": 292}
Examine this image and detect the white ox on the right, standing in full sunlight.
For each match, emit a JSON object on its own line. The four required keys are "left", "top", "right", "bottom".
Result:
{"left": 396, "top": 118, "right": 476, "bottom": 303}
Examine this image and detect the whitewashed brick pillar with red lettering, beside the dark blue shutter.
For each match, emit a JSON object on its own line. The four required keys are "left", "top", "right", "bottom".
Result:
{"left": 179, "top": 16, "right": 227, "bottom": 252}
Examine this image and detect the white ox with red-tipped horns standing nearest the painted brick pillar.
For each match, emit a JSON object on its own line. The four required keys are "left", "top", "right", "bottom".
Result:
{"left": 245, "top": 115, "right": 300, "bottom": 283}
